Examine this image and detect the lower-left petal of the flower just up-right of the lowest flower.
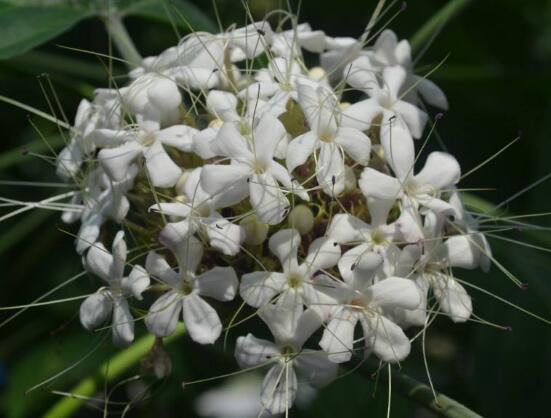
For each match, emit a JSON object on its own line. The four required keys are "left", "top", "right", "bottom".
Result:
{"left": 319, "top": 308, "right": 358, "bottom": 363}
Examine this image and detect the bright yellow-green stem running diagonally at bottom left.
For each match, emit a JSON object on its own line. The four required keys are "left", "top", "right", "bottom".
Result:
{"left": 44, "top": 323, "right": 185, "bottom": 418}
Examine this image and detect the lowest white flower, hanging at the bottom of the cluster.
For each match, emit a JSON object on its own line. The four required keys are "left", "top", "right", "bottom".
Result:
{"left": 235, "top": 304, "right": 337, "bottom": 414}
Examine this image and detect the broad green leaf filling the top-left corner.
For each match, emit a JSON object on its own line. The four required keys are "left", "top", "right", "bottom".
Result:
{"left": 0, "top": 1, "right": 92, "bottom": 59}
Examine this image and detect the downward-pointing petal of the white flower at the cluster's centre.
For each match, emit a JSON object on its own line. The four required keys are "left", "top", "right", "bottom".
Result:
{"left": 249, "top": 174, "right": 289, "bottom": 225}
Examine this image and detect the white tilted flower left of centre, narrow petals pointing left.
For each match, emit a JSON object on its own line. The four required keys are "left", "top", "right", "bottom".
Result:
{"left": 150, "top": 168, "right": 245, "bottom": 255}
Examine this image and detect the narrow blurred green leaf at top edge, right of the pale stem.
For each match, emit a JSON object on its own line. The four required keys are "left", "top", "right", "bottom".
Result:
{"left": 123, "top": 0, "right": 218, "bottom": 32}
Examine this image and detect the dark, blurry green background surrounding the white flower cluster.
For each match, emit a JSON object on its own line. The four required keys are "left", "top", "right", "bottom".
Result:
{"left": 0, "top": 0, "right": 551, "bottom": 418}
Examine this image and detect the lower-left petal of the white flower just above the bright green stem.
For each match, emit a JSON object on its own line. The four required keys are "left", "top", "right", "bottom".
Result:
{"left": 145, "top": 291, "right": 182, "bottom": 337}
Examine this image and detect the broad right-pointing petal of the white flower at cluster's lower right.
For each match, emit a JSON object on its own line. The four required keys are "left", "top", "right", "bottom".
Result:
{"left": 365, "top": 277, "right": 421, "bottom": 309}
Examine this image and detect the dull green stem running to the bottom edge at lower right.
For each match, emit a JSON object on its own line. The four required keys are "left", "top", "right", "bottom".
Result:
{"left": 360, "top": 360, "right": 482, "bottom": 418}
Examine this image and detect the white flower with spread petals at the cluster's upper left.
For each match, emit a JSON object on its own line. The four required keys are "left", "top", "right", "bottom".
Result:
{"left": 93, "top": 122, "right": 196, "bottom": 187}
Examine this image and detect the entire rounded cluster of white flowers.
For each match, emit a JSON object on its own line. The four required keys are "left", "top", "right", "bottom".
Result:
{"left": 58, "top": 22, "right": 490, "bottom": 414}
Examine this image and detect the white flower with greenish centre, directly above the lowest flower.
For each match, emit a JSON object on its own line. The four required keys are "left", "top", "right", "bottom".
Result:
{"left": 239, "top": 229, "right": 341, "bottom": 316}
